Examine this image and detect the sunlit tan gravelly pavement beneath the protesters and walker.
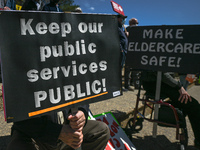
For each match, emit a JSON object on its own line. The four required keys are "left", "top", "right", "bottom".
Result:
{"left": 0, "top": 85, "right": 200, "bottom": 150}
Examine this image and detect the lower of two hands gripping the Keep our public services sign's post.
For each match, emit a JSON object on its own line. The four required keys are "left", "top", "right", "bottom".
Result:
{"left": 59, "top": 125, "right": 83, "bottom": 149}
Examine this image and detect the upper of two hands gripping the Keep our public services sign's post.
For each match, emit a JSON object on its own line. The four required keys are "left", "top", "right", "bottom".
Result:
{"left": 67, "top": 110, "right": 86, "bottom": 131}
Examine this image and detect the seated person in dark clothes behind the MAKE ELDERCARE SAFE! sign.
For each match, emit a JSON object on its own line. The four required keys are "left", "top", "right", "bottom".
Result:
{"left": 141, "top": 71, "right": 200, "bottom": 148}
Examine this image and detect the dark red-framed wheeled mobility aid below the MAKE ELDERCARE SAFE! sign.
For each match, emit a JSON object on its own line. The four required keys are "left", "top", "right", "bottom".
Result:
{"left": 125, "top": 77, "right": 188, "bottom": 150}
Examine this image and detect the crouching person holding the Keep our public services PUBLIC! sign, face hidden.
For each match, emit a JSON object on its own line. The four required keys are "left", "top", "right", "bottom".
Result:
{"left": 7, "top": 107, "right": 110, "bottom": 150}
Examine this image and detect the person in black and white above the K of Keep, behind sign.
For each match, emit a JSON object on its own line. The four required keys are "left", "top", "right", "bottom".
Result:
{"left": 22, "top": 0, "right": 45, "bottom": 11}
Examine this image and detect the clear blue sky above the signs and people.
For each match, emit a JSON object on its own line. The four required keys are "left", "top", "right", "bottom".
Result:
{"left": 74, "top": 0, "right": 200, "bottom": 26}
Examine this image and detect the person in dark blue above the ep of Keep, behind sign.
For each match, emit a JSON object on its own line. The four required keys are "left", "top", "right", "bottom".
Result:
{"left": 43, "top": 0, "right": 62, "bottom": 12}
